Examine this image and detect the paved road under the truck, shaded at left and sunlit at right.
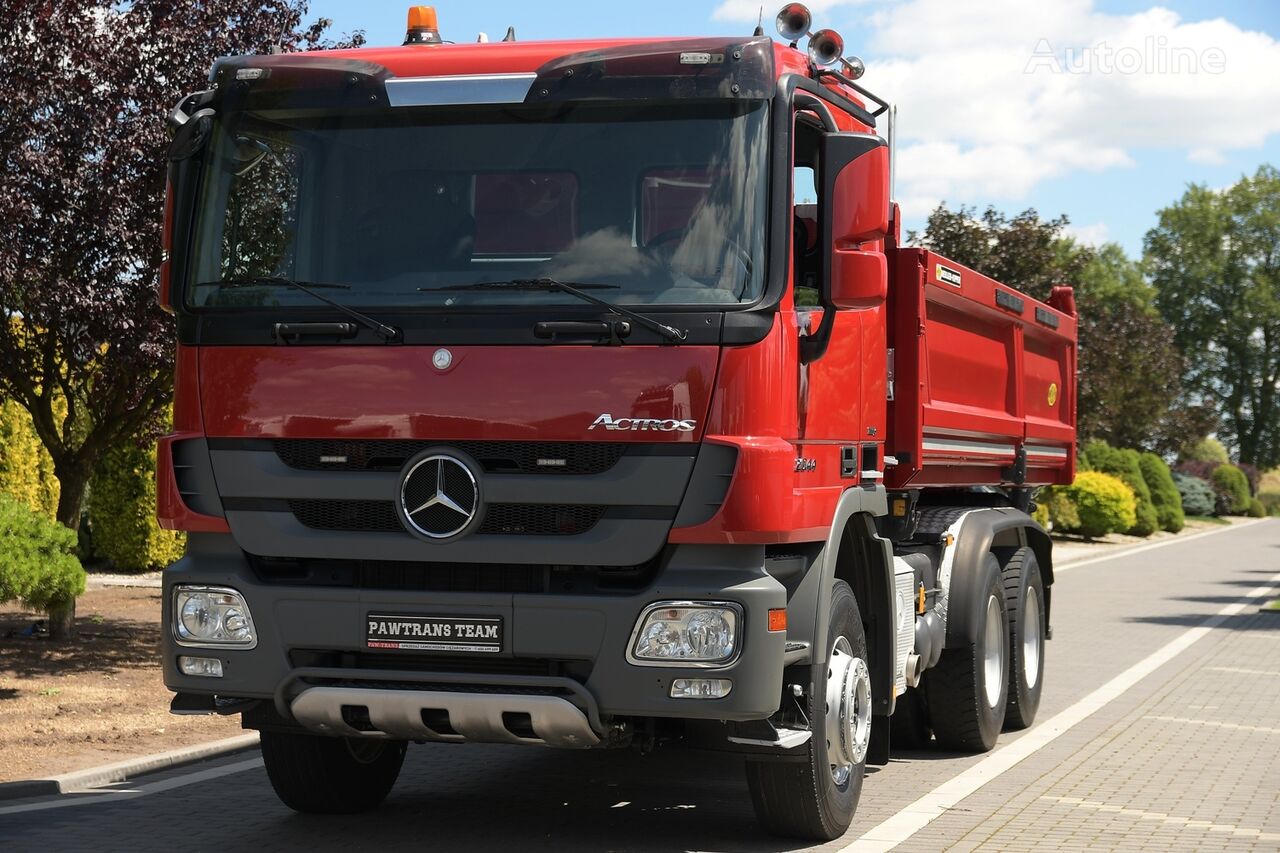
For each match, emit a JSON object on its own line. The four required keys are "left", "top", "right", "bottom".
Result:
{"left": 0, "top": 521, "right": 1280, "bottom": 853}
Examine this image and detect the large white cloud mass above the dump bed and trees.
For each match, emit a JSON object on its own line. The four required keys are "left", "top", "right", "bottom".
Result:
{"left": 742, "top": 0, "right": 1280, "bottom": 216}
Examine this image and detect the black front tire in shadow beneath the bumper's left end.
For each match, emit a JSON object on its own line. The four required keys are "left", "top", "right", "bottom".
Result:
{"left": 261, "top": 731, "right": 407, "bottom": 815}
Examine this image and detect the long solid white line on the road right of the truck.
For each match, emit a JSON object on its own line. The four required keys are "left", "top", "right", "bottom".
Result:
{"left": 841, "top": 560, "right": 1280, "bottom": 853}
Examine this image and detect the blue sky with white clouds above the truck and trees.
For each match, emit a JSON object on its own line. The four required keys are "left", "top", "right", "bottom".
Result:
{"left": 304, "top": 0, "right": 1280, "bottom": 256}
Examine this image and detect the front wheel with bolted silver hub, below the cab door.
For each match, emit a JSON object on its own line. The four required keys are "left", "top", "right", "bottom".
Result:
{"left": 746, "top": 580, "right": 872, "bottom": 841}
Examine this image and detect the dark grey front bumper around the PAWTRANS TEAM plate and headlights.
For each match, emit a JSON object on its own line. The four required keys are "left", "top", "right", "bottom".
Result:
{"left": 163, "top": 534, "right": 786, "bottom": 740}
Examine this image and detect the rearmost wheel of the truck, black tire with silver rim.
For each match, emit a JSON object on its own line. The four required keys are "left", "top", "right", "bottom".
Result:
{"left": 1004, "top": 548, "right": 1044, "bottom": 731}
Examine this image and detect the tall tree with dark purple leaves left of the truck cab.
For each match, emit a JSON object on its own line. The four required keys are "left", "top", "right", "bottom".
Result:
{"left": 0, "top": 0, "right": 362, "bottom": 635}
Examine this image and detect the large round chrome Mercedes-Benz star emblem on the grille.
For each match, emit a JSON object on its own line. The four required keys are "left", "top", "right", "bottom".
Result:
{"left": 401, "top": 452, "right": 480, "bottom": 539}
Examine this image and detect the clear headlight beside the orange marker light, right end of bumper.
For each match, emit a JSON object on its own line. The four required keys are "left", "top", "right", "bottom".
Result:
{"left": 627, "top": 601, "right": 742, "bottom": 666}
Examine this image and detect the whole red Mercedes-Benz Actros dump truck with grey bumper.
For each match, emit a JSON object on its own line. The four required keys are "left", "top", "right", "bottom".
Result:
{"left": 159, "top": 4, "right": 1076, "bottom": 839}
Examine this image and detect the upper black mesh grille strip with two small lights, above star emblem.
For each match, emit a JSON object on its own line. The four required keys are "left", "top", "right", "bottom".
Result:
{"left": 274, "top": 438, "right": 627, "bottom": 474}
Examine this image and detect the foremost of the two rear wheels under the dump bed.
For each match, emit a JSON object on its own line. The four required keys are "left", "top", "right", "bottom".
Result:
{"left": 924, "top": 553, "right": 1009, "bottom": 752}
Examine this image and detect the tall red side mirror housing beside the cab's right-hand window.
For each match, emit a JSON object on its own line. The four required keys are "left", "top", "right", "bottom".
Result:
{"left": 819, "top": 133, "right": 890, "bottom": 309}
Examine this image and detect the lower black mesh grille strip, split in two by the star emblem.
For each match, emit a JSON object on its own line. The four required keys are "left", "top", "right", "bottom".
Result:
{"left": 289, "top": 500, "right": 608, "bottom": 537}
